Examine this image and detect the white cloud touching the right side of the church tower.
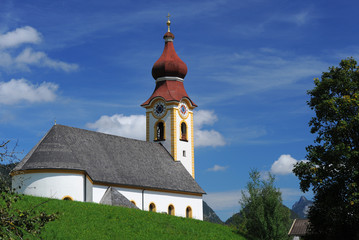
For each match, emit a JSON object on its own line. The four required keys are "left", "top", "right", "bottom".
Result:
{"left": 193, "top": 110, "right": 226, "bottom": 147}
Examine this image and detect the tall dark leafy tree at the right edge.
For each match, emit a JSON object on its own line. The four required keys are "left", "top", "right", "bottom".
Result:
{"left": 293, "top": 58, "right": 359, "bottom": 239}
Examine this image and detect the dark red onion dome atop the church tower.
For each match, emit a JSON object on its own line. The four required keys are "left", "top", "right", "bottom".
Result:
{"left": 152, "top": 32, "right": 187, "bottom": 79}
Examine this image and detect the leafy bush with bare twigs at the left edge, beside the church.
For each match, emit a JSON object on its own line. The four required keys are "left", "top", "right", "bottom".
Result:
{"left": 0, "top": 141, "right": 56, "bottom": 239}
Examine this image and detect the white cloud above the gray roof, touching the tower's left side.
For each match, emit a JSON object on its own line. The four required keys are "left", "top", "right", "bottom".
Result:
{"left": 86, "top": 114, "right": 146, "bottom": 140}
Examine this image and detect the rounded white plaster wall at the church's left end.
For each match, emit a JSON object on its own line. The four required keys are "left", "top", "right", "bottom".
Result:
{"left": 12, "top": 173, "right": 85, "bottom": 201}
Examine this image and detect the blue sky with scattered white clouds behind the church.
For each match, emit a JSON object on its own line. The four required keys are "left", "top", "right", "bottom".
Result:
{"left": 0, "top": 0, "right": 359, "bottom": 220}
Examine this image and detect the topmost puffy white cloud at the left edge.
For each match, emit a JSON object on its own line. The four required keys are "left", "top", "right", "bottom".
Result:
{"left": 0, "top": 26, "right": 41, "bottom": 48}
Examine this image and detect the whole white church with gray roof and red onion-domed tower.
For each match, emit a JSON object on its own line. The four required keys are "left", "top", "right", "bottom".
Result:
{"left": 11, "top": 20, "right": 205, "bottom": 220}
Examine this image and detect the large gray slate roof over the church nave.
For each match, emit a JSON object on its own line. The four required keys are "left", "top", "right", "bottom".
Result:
{"left": 13, "top": 125, "right": 205, "bottom": 194}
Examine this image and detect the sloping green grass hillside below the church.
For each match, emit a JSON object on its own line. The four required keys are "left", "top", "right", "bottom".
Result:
{"left": 8, "top": 196, "right": 245, "bottom": 240}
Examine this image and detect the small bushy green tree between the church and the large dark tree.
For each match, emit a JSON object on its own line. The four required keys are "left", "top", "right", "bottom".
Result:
{"left": 239, "top": 170, "right": 291, "bottom": 240}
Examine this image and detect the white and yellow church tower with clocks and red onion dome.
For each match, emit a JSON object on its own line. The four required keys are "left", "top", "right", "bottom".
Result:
{"left": 141, "top": 20, "right": 197, "bottom": 178}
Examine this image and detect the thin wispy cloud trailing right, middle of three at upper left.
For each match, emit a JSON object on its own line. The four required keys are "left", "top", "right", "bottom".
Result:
{"left": 14, "top": 48, "right": 78, "bottom": 72}
